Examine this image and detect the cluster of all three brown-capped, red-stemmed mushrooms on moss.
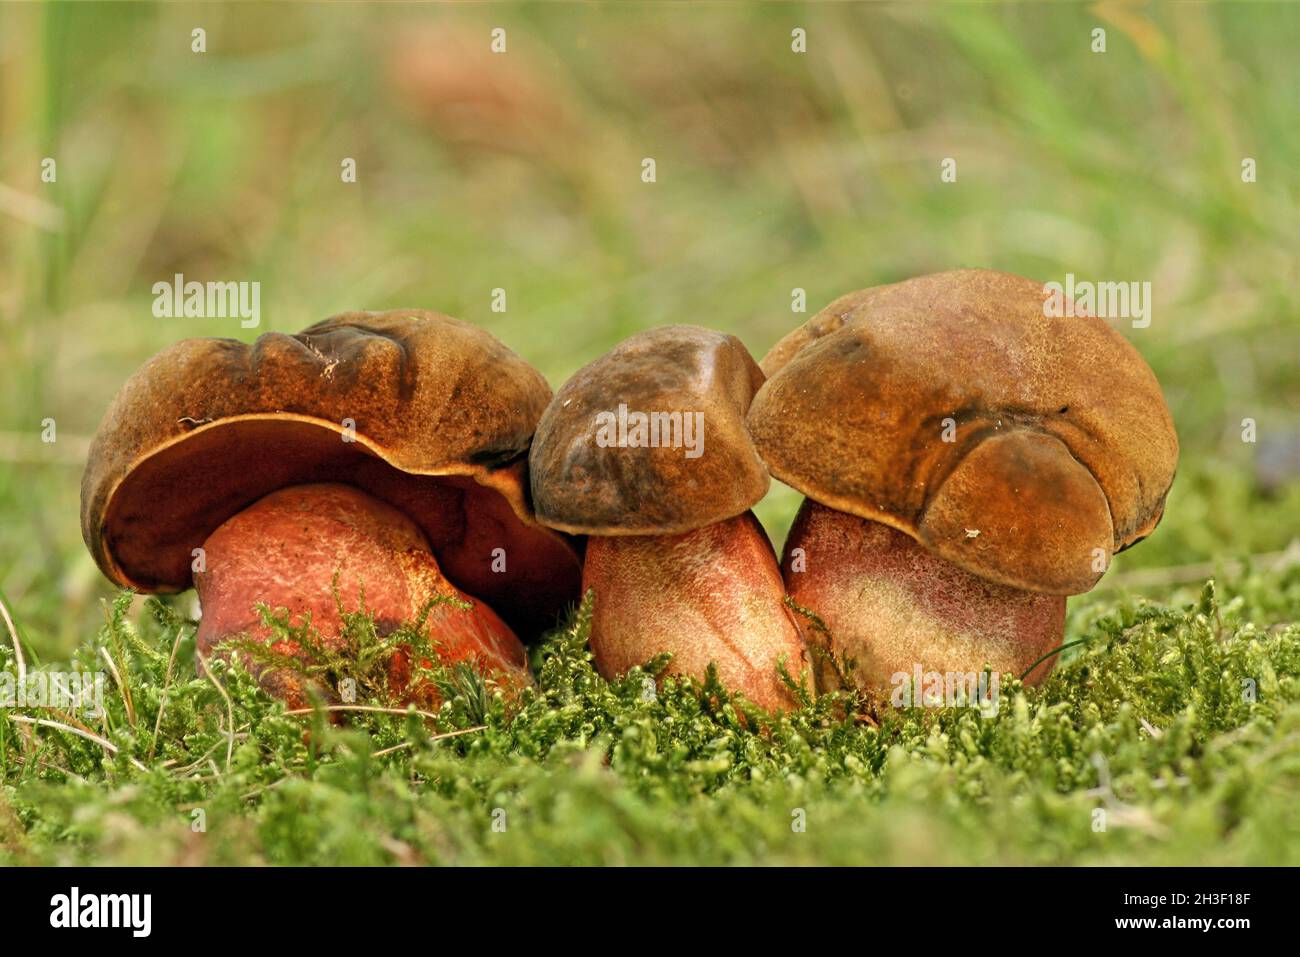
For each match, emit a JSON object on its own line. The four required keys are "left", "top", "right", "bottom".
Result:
{"left": 82, "top": 270, "right": 1178, "bottom": 709}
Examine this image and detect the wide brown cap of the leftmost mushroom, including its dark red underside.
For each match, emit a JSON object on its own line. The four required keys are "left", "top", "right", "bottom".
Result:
{"left": 82, "top": 309, "right": 581, "bottom": 629}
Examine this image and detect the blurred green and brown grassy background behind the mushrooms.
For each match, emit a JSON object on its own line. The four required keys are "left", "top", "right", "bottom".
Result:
{"left": 0, "top": 4, "right": 1300, "bottom": 658}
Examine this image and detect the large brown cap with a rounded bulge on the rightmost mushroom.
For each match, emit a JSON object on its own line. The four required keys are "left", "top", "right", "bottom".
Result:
{"left": 749, "top": 269, "right": 1178, "bottom": 594}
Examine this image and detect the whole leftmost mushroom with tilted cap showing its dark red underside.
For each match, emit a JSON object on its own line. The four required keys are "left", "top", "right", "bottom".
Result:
{"left": 82, "top": 311, "right": 581, "bottom": 702}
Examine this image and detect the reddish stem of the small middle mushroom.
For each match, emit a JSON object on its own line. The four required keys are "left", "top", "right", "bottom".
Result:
{"left": 582, "top": 512, "right": 809, "bottom": 710}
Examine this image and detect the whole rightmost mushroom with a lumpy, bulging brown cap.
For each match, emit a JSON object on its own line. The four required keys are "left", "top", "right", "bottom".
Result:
{"left": 748, "top": 269, "right": 1178, "bottom": 688}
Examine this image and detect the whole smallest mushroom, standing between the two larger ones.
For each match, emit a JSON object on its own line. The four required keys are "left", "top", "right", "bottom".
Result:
{"left": 529, "top": 325, "right": 807, "bottom": 710}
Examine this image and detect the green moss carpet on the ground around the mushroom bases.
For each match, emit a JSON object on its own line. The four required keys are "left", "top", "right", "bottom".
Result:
{"left": 0, "top": 570, "right": 1300, "bottom": 865}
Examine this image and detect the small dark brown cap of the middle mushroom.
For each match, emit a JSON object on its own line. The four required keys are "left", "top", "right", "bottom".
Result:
{"left": 529, "top": 325, "right": 768, "bottom": 536}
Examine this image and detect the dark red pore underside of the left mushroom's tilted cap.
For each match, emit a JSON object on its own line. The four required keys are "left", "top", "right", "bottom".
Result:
{"left": 88, "top": 416, "right": 581, "bottom": 637}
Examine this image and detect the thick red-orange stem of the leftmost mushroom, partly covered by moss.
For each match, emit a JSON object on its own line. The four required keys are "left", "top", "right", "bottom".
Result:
{"left": 194, "top": 484, "right": 528, "bottom": 706}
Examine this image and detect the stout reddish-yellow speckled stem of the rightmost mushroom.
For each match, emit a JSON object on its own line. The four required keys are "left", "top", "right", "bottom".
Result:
{"left": 781, "top": 498, "right": 1065, "bottom": 690}
